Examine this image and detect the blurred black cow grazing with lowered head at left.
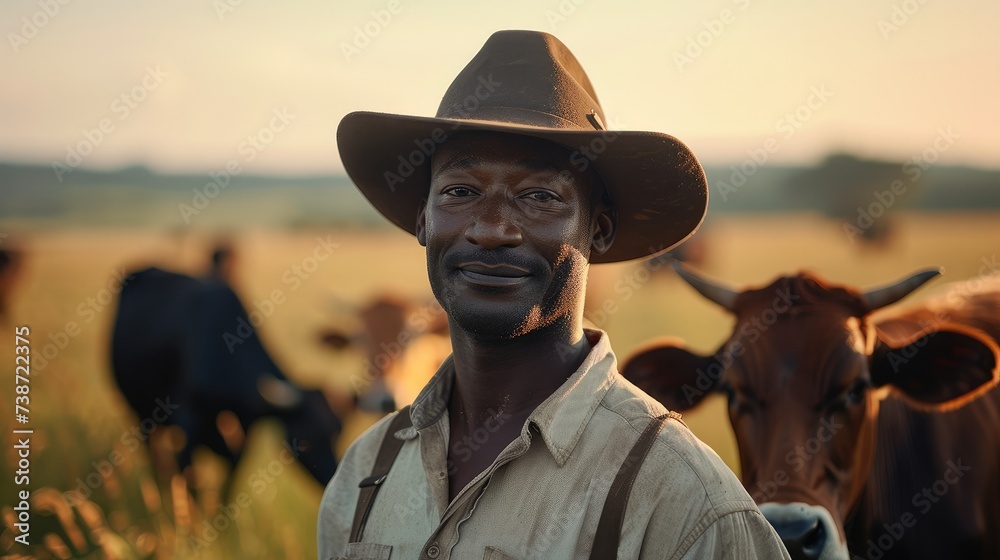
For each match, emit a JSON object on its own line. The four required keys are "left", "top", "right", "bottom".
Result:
{"left": 111, "top": 268, "right": 341, "bottom": 492}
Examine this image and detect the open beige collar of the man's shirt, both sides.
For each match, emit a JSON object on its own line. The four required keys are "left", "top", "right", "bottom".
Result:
{"left": 397, "top": 329, "right": 617, "bottom": 467}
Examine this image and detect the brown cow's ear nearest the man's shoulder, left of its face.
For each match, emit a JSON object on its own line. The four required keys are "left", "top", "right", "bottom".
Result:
{"left": 621, "top": 339, "right": 722, "bottom": 412}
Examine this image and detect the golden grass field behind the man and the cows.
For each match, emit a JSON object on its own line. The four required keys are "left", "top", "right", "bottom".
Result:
{"left": 0, "top": 214, "right": 1000, "bottom": 559}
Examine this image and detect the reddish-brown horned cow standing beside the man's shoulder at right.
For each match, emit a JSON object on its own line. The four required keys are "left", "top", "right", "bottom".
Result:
{"left": 622, "top": 265, "right": 1000, "bottom": 560}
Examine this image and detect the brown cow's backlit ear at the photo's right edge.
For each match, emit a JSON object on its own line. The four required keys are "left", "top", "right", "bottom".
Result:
{"left": 871, "top": 325, "right": 1000, "bottom": 410}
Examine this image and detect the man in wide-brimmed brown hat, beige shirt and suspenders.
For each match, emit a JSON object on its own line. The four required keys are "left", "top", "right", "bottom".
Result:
{"left": 319, "top": 31, "right": 788, "bottom": 560}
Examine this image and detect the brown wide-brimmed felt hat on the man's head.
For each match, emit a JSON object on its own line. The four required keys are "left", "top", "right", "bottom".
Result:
{"left": 337, "top": 31, "right": 708, "bottom": 263}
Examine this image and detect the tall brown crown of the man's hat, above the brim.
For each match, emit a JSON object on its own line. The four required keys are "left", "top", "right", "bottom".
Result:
{"left": 437, "top": 31, "right": 605, "bottom": 130}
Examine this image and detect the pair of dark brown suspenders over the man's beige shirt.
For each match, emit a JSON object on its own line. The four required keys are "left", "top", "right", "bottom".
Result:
{"left": 348, "top": 406, "right": 681, "bottom": 560}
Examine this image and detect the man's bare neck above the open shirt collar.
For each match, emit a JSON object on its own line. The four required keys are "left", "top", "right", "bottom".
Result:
{"left": 449, "top": 320, "right": 591, "bottom": 431}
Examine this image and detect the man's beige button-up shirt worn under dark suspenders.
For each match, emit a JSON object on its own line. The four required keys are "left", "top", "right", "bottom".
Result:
{"left": 319, "top": 331, "right": 788, "bottom": 560}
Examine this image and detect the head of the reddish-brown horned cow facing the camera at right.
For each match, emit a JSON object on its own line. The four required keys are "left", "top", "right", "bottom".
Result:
{"left": 622, "top": 265, "right": 998, "bottom": 559}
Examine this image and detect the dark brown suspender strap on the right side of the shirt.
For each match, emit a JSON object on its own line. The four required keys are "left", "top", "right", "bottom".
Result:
{"left": 590, "top": 412, "right": 680, "bottom": 560}
